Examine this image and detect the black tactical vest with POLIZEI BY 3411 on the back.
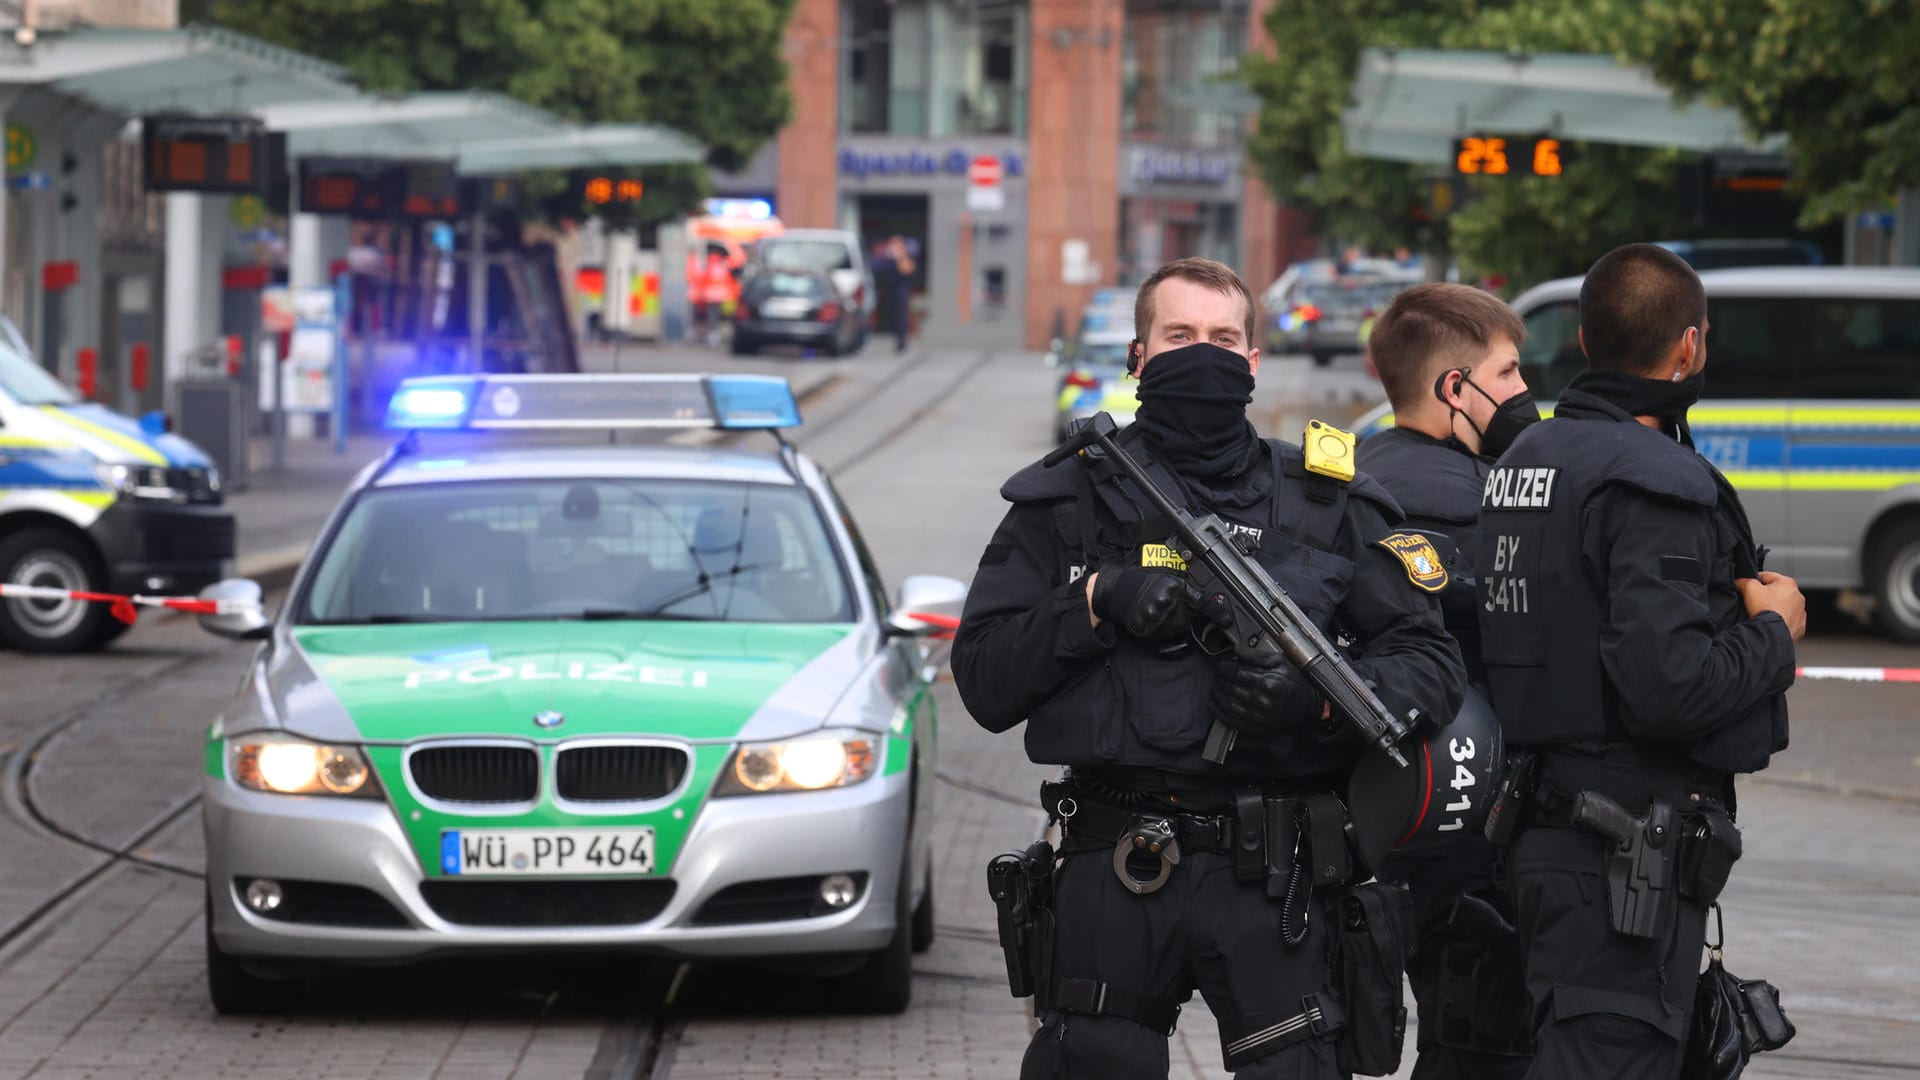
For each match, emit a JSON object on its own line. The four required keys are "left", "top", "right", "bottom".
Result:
{"left": 1475, "top": 411, "right": 1718, "bottom": 746}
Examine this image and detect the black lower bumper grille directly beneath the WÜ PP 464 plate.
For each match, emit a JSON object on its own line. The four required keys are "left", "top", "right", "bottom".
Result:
{"left": 420, "top": 878, "right": 674, "bottom": 926}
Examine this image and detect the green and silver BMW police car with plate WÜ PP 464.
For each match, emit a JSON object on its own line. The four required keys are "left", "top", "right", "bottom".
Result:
{"left": 204, "top": 375, "right": 966, "bottom": 1013}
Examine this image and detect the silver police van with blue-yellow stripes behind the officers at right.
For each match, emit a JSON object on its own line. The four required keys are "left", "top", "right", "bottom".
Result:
{"left": 1359, "top": 267, "right": 1920, "bottom": 642}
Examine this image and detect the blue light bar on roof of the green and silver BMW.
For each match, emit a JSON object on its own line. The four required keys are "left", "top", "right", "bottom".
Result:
{"left": 386, "top": 375, "right": 801, "bottom": 430}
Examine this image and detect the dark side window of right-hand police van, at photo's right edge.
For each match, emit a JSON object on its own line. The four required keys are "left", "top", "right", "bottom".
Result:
{"left": 1797, "top": 298, "right": 1920, "bottom": 398}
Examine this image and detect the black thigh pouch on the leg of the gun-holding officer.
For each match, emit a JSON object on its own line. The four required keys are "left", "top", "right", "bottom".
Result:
{"left": 1334, "top": 884, "right": 1413, "bottom": 1076}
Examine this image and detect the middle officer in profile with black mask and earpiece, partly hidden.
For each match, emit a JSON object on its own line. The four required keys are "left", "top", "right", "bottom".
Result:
{"left": 1359, "top": 282, "right": 1540, "bottom": 1080}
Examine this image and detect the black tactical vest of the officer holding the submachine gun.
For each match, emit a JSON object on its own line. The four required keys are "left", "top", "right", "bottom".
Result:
{"left": 1000, "top": 424, "right": 1398, "bottom": 780}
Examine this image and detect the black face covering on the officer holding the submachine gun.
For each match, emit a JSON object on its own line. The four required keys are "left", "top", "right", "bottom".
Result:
{"left": 1133, "top": 342, "right": 1258, "bottom": 477}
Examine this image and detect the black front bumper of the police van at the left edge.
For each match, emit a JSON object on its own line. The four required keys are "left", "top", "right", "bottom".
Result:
{"left": 88, "top": 498, "right": 234, "bottom": 594}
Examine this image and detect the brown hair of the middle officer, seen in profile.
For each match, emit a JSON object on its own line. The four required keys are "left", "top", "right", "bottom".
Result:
{"left": 1367, "top": 281, "right": 1526, "bottom": 409}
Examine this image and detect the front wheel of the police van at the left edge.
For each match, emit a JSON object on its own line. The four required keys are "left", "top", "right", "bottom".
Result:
{"left": 0, "top": 528, "right": 113, "bottom": 653}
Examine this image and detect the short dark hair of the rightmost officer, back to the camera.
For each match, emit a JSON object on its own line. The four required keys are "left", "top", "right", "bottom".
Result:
{"left": 1580, "top": 244, "right": 1707, "bottom": 375}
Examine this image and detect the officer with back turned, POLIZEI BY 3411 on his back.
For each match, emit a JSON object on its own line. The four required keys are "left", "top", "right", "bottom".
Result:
{"left": 1475, "top": 244, "right": 1807, "bottom": 1080}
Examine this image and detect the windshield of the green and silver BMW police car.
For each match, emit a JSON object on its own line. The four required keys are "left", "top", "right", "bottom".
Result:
{"left": 296, "top": 479, "right": 852, "bottom": 625}
